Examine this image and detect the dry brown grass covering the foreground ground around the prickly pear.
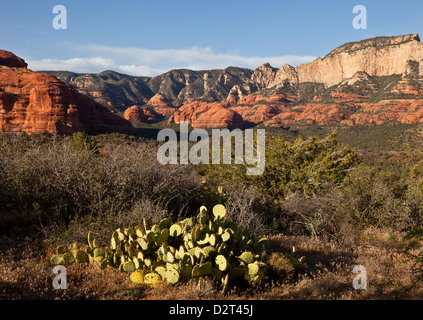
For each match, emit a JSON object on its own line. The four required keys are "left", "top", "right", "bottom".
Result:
{"left": 0, "top": 229, "right": 423, "bottom": 300}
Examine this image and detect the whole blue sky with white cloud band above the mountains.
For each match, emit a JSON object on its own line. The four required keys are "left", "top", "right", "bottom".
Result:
{"left": 0, "top": 0, "right": 423, "bottom": 76}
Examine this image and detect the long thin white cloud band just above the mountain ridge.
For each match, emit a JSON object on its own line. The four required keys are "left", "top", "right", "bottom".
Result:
{"left": 27, "top": 45, "right": 315, "bottom": 76}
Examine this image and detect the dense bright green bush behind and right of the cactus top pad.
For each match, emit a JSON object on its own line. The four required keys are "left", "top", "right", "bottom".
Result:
{"left": 208, "top": 131, "right": 359, "bottom": 201}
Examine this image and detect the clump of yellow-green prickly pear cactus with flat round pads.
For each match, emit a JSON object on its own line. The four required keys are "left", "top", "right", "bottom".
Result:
{"left": 50, "top": 204, "right": 268, "bottom": 291}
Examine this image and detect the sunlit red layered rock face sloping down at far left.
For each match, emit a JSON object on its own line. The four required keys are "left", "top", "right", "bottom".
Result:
{"left": 0, "top": 50, "right": 134, "bottom": 134}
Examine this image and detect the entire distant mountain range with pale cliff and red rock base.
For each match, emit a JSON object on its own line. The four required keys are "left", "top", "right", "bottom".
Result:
{"left": 23, "top": 34, "right": 423, "bottom": 128}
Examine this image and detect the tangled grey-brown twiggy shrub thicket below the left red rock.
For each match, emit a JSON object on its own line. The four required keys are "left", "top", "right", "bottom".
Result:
{"left": 0, "top": 134, "right": 204, "bottom": 235}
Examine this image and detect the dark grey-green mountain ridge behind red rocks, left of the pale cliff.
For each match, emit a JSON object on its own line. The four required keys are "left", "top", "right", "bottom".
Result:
{"left": 43, "top": 67, "right": 253, "bottom": 111}
